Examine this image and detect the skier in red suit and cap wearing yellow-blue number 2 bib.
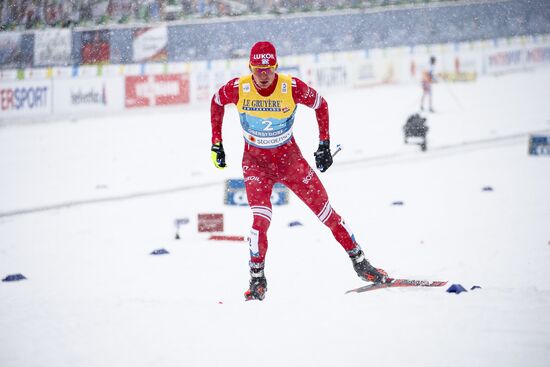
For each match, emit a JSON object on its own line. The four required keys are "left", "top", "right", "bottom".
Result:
{"left": 210, "top": 42, "right": 387, "bottom": 300}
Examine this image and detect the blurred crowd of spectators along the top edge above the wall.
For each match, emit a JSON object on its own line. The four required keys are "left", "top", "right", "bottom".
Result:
{"left": 0, "top": 0, "right": 456, "bottom": 31}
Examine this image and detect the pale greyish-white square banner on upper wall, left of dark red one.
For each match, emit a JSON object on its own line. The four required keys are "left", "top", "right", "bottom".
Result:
{"left": 34, "top": 29, "right": 72, "bottom": 66}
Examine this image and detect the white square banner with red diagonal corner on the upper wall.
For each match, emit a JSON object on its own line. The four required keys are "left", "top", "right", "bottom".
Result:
{"left": 132, "top": 27, "right": 168, "bottom": 62}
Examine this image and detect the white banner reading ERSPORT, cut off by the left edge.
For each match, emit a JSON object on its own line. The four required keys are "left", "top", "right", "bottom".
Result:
{"left": 0, "top": 80, "right": 52, "bottom": 119}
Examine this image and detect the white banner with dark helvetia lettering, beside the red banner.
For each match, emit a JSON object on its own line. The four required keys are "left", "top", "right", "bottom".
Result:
{"left": 53, "top": 77, "right": 124, "bottom": 114}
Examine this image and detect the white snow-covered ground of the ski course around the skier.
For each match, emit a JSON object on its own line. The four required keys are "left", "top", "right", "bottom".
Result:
{"left": 0, "top": 69, "right": 550, "bottom": 367}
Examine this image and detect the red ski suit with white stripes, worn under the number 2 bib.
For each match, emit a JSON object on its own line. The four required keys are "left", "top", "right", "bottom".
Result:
{"left": 211, "top": 75, "right": 358, "bottom": 263}
